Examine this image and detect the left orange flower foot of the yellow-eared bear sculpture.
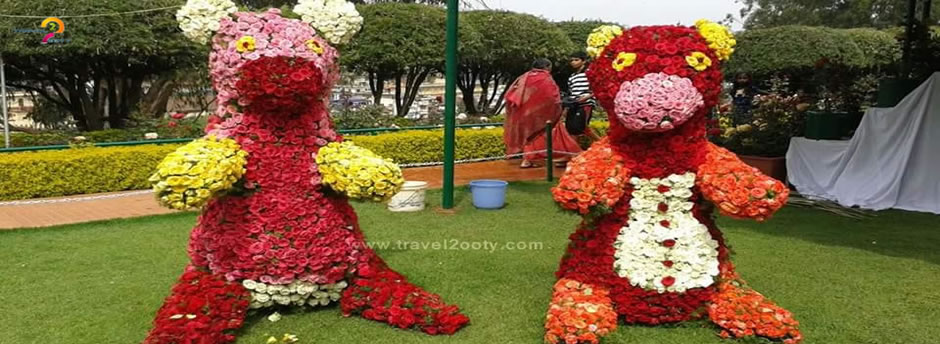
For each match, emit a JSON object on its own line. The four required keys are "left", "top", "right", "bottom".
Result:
{"left": 545, "top": 278, "right": 617, "bottom": 344}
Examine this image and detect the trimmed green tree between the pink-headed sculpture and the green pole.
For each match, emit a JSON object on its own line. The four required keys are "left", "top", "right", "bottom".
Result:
{"left": 341, "top": 3, "right": 445, "bottom": 116}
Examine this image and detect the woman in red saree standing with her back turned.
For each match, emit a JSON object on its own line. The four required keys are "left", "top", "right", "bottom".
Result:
{"left": 503, "top": 59, "right": 581, "bottom": 168}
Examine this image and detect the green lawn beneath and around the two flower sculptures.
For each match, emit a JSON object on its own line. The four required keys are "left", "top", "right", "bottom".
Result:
{"left": 0, "top": 183, "right": 940, "bottom": 344}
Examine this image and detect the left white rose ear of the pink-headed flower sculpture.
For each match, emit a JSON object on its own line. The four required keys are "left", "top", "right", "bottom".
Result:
{"left": 176, "top": 0, "right": 238, "bottom": 44}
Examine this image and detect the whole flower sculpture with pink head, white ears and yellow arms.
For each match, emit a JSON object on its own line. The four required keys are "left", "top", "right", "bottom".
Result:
{"left": 144, "top": 0, "right": 468, "bottom": 344}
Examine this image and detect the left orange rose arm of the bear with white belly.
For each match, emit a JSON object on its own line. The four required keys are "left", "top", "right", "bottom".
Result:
{"left": 552, "top": 138, "right": 630, "bottom": 215}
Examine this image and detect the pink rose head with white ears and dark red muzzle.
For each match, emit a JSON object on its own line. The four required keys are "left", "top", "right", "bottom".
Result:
{"left": 177, "top": 0, "right": 362, "bottom": 129}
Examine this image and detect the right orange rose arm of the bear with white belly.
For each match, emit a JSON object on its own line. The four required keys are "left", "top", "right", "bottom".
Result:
{"left": 696, "top": 143, "right": 790, "bottom": 221}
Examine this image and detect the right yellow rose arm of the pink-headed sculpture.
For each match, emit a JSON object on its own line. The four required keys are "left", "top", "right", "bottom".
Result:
{"left": 316, "top": 141, "right": 405, "bottom": 202}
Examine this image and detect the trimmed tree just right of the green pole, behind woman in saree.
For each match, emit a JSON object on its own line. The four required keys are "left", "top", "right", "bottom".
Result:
{"left": 457, "top": 10, "right": 575, "bottom": 113}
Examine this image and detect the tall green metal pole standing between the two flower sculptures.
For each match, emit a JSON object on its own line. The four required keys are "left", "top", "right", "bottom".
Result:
{"left": 441, "top": 0, "right": 460, "bottom": 209}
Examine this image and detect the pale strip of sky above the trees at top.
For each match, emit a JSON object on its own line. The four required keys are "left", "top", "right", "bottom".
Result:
{"left": 488, "top": 0, "right": 742, "bottom": 29}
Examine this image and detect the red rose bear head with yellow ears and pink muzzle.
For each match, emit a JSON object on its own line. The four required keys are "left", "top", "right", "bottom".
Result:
{"left": 587, "top": 20, "right": 735, "bottom": 132}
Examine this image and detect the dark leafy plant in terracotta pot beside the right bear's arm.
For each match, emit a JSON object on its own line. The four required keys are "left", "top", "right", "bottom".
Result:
{"left": 712, "top": 86, "right": 809, "bottom": 180}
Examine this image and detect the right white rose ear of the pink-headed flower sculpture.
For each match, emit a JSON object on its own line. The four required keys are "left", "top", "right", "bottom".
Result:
{"left": 293, "top": 0, "right": 362, "bottom": 44}
